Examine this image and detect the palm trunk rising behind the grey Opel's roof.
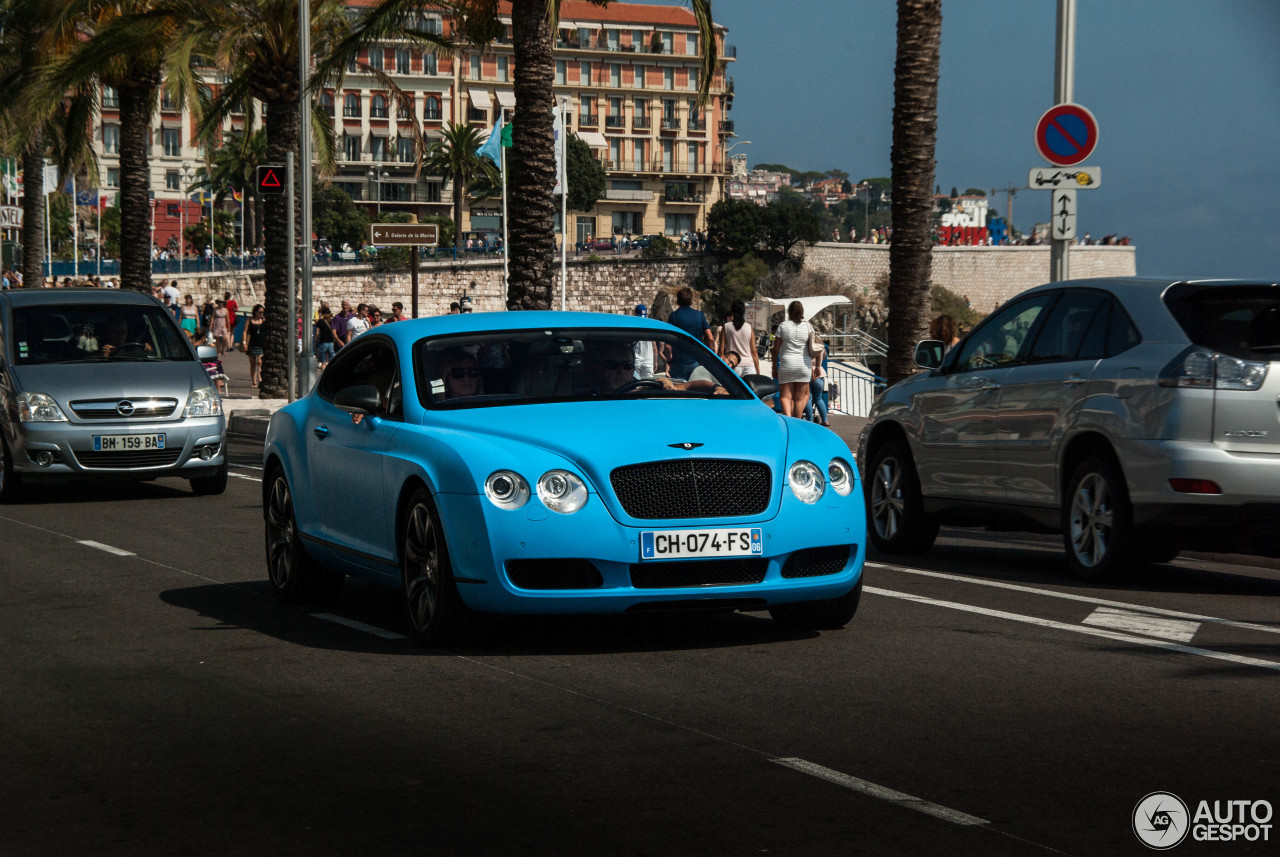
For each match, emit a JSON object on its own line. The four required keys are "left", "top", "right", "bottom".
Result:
{"left": 119, "top": 69, "right": 160, "bottom": 294}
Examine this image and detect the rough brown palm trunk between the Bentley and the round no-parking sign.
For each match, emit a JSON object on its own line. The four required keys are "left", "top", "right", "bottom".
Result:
{"left": 887, "top": 0, "right": 942, "bottom": 384}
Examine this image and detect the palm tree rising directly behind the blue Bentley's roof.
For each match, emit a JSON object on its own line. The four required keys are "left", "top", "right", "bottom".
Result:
{"left": 355, "top": 0, "right": 719, "bottom": 310}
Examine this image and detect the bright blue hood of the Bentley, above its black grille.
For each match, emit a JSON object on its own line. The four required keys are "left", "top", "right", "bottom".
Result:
{"left": 430, "top": 399, "right": 788, "bottom": 486}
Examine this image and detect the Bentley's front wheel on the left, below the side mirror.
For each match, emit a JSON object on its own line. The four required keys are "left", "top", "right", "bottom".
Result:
{"left": 401, "top": 489, "right": 472, "bottom": 646}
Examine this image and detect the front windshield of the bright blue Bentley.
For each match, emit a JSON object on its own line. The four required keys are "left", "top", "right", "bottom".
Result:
{"left": 413, "top": 329, "right": 753, "bottom": 408}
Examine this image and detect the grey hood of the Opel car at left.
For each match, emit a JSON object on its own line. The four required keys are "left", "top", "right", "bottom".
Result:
{"left": 9, "top": 361, "right": 209, "bottom": 405}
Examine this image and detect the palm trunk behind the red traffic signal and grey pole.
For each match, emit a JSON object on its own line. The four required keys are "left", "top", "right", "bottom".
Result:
{"left": 259, "top": 100, "right": 301, "bottom": 399}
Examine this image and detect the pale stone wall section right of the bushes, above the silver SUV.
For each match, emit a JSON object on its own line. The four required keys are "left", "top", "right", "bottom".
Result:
{"left": 804, "top": 242, "right": 1137, "bottom": 313}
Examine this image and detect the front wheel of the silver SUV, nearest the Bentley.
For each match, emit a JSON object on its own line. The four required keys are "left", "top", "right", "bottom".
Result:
{"left": 865, "top": 441, "right": 938, "bottom": 554}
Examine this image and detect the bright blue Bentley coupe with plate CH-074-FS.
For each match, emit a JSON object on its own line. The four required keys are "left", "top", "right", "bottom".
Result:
{"left": 262, "top": 312, "right": 867, "bottom": 645}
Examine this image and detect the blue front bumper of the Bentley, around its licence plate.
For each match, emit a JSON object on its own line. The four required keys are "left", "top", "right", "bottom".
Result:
{"left": 436, "top": 485, "right": 867, "bottom": 614}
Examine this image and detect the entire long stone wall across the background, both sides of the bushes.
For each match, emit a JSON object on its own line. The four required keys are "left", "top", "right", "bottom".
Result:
{"left": 169, "top": 242, "right": 1137, "bottom": 316}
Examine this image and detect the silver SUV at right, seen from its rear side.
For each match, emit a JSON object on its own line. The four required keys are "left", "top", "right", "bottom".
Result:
{"left": 858, "top": 279, "right": 1280, "bottom": 581}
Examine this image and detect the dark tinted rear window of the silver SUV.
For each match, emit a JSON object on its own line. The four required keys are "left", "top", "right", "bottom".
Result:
{"left": 1165, "top": 284, "right": 1280, "bottom": 361}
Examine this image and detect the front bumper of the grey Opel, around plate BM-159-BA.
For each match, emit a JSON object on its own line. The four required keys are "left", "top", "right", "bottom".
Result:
{"left": 9, "top": 416, "right": 227, "bottom": 482}
